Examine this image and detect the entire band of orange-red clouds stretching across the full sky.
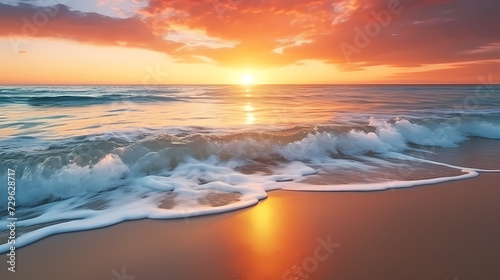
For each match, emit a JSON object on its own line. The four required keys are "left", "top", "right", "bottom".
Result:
{"left": 0, "top": 0, "right": 500, "bottom": 70}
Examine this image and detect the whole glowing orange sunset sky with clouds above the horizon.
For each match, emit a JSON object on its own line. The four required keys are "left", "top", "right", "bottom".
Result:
{"left": 0, "top": 0, "right": 500, "bottom": 84}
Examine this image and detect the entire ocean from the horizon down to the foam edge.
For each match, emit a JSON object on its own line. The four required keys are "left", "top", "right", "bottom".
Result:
{"left": 0, "top": 85, "right": 500, "bottom": 252}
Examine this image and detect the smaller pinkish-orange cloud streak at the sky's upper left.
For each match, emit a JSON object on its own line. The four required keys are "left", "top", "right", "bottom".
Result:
{"left": 0, "top": 3, "right": 182, "bottom": 52}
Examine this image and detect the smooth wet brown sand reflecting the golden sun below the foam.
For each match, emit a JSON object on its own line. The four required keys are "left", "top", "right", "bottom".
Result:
{"left": 0, "top": 174, "right": 500, "bottom": 280}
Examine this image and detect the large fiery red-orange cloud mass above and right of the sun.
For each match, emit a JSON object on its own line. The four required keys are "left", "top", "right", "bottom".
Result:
{"left": 136, "top": 0, "right": 500, "bottom": 70}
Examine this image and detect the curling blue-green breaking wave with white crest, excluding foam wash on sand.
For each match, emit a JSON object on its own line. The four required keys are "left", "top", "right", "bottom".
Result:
{"left": 0, "top": 117, "right": 500, "bottom": 204}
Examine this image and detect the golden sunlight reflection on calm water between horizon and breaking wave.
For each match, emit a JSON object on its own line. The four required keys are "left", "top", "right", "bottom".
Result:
{"left": 2, "top": 84, "right": 356, "bottom": 137}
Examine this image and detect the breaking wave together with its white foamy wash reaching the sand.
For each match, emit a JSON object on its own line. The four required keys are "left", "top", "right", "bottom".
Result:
{"left": 0, "top": 117, "right": 500, "bottom": 251}
